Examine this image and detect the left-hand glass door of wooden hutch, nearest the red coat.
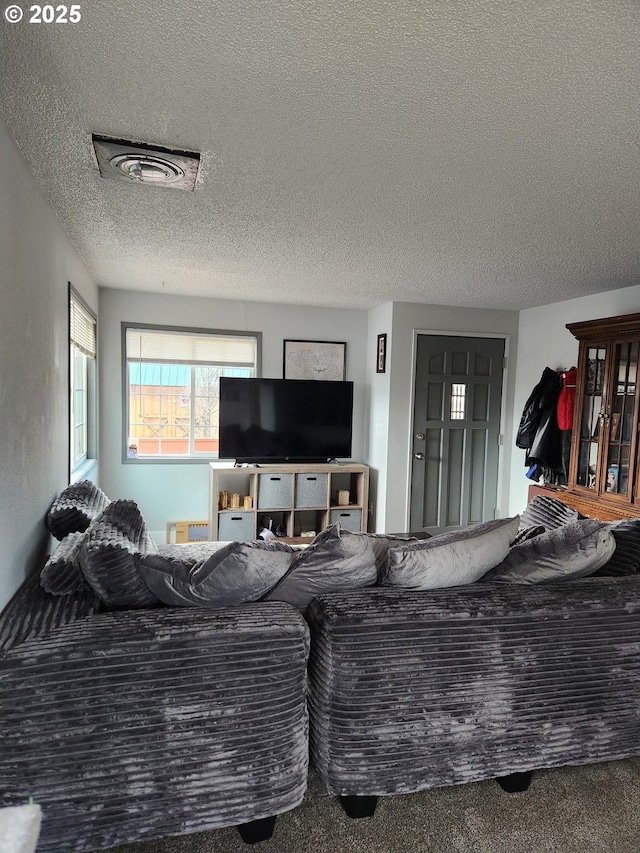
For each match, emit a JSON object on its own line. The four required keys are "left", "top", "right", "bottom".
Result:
{"left": 576, "top": 344, "right": 607, "bottom": 492}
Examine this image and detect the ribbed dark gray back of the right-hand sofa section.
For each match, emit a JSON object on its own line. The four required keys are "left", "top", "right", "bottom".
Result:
{"left": 308, "top": 576, "right": 640, "bottom": 796}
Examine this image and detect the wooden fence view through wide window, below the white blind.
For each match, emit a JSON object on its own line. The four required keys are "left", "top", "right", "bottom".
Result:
{"left": 127, "top": 362, "right": 252, "bottom": 458}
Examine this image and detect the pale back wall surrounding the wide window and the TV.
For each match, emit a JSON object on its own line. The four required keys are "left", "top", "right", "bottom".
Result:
{"left": 99, "top": 288, "right": 367, "bottom": 541}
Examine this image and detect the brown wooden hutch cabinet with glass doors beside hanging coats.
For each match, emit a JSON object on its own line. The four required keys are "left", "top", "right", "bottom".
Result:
{"left": 536, "top": 314, "right": 640, "bottom": 521}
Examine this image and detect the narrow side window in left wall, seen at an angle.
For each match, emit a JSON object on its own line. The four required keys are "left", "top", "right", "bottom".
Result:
{"left": 69, "top": 285, "right": 97, "bottom": 472}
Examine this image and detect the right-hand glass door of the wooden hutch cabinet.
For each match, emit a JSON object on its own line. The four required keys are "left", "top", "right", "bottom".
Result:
{"left": 602, "top": 341, "right": 640, "bottom": 497}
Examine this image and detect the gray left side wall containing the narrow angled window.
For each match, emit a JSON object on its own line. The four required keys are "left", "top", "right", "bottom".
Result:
{"left": 0, "top": 120, "right": 97, "bottom": 609}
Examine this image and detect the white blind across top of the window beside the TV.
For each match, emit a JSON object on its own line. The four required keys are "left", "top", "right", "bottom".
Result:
{"left": 126, "top": 327, "right": 257, "bottom": 367}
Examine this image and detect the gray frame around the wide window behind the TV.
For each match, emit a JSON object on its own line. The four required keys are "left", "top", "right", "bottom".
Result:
{"left": 121, "top": 320, "right": 262, "bottom": 465}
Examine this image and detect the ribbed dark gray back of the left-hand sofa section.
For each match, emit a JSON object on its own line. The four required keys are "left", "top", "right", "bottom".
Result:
{"left": 0, "top": 604, "right": 309, "bottom": 853}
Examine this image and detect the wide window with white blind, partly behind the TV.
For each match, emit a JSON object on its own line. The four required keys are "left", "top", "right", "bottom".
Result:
{"left": 123, "top": 323, "right": 261, "bottom": 460}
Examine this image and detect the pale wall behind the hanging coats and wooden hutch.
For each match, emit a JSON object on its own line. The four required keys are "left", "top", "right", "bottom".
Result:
{"left": 509, "top": 285, "right": 640, "bottom": 514}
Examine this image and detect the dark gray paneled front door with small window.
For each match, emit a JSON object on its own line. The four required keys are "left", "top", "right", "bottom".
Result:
{"left": 409, "top": 335, "right": 504, "bottom": 534}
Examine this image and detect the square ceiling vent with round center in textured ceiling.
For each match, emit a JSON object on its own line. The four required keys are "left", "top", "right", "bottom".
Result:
{"left": 92, "top": 134, "right": 200, "bottom": 190}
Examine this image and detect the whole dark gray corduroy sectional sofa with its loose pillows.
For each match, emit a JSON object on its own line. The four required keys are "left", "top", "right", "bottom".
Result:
{"left": 0, "top": 486, "right": 640, "bottom": 853}
